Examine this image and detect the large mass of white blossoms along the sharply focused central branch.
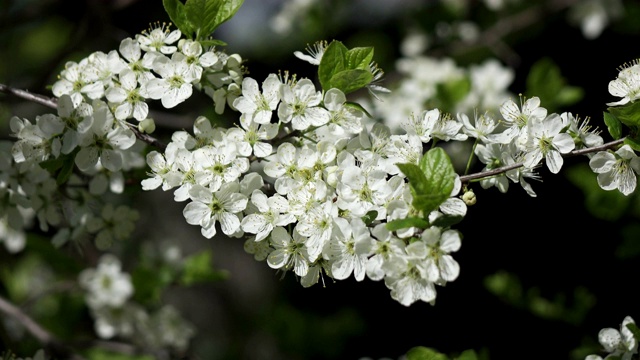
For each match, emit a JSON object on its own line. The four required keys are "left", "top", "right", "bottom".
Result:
{"left": 5, "top": 14, "right": 640, "bottom": 316}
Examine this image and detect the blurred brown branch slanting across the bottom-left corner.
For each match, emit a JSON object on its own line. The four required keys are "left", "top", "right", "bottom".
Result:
{"left": 0, "top": 296, "right": 84, "bottom": 360}
